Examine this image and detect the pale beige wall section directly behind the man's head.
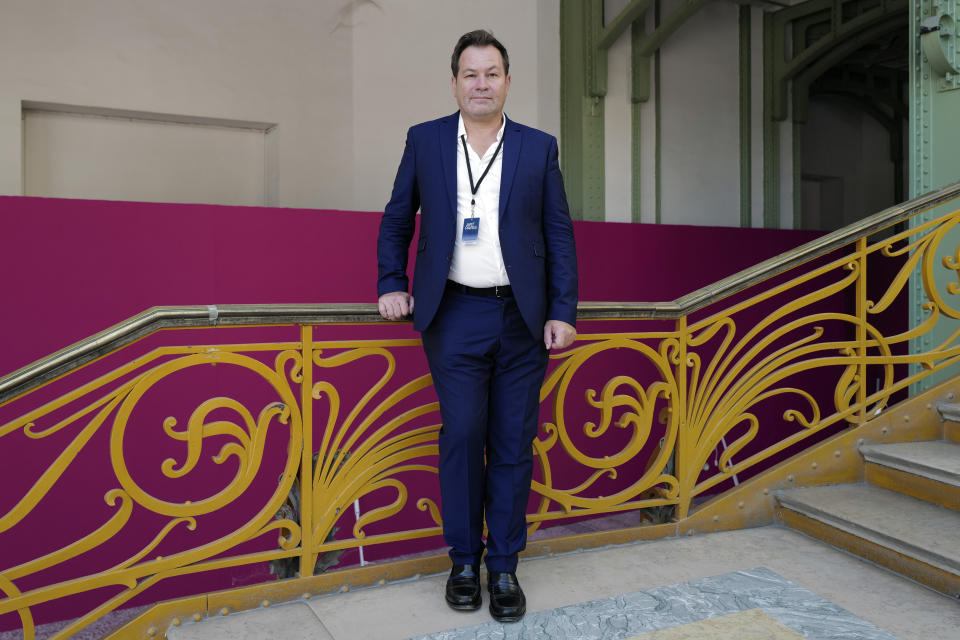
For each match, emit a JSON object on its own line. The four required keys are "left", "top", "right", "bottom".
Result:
{"left": 352, "top": 0, "right": 560, "bottom": 215}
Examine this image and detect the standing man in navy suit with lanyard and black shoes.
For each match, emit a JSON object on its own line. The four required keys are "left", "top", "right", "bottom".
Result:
{"left": 377, "top": 30, "right": 577, "bottom": 621}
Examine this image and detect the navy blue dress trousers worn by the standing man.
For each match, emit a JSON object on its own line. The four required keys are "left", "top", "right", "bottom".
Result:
{"left": 423, "top": 289, "right": 548, "bottom": 572}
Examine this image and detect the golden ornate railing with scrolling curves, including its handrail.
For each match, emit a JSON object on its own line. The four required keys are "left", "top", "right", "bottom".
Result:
{"left": 0, "top": 184, "right": 960, "bottom": 638}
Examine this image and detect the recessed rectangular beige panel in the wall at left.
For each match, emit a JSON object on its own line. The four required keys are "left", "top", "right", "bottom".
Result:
{"left": 23, "top": 104, "right": 270, "bottom": 206}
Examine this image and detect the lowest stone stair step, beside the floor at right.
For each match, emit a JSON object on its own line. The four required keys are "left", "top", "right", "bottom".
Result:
{"left": 777, "top": 484, "right": 960, "bottom": 597}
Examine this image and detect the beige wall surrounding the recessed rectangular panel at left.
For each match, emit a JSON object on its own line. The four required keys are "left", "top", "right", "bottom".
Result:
{"left": 0, "top": 0, "right": 353, "bottom": 206}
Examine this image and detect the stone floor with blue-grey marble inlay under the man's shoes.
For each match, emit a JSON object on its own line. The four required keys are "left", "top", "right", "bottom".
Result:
{"left": 168, "top": 527, "right": 960, "bottom": 640}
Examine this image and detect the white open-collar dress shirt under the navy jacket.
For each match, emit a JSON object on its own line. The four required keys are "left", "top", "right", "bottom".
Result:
{"left": 448, "top": 116, "right": 510, "bottom": 287}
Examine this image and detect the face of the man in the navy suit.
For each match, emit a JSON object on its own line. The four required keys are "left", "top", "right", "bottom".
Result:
{"left": 452, "top": 46, "right": 510, "bottom": 120}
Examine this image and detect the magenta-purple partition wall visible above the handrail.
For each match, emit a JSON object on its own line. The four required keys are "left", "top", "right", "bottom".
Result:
{"left": 0, "top": 196, "right": 819, "bottom": 375}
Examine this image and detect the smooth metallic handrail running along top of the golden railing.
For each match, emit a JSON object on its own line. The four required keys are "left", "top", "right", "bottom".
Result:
{"left": 0, "top": 182, "right": 960, "bottom": 404}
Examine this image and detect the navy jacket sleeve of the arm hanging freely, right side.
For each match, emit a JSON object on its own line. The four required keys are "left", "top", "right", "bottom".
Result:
{"left": 543, "top": 138, "right": 577, "bottom": 325}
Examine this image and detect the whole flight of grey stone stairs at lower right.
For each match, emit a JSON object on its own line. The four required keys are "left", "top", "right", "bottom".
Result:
{"left": 777, "top": 404, "right": 960, "bottom": 598}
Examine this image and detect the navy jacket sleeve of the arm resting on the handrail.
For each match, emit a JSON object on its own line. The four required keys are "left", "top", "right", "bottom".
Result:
{"left": 377, "top": 131, "right": 420, "bottom": 296}
